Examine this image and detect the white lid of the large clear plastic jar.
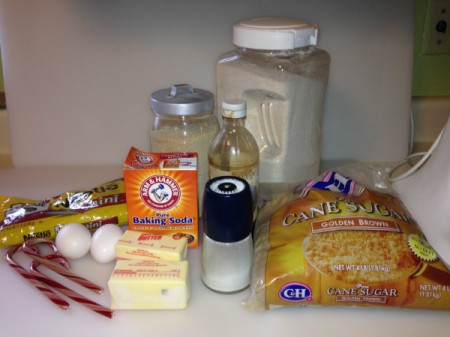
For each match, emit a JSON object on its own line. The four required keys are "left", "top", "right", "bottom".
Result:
{"left": 233, "top": 18, "right": 318, "bottom": 50}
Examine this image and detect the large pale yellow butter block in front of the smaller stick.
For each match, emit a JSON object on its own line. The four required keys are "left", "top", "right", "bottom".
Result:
{"left": 108, "top": 260, "right": 190, "bottom": 310}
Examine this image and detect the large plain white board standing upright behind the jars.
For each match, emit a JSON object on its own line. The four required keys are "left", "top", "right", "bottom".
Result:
{"left": 0, "top": 0, "right": 414, "bottom": 166}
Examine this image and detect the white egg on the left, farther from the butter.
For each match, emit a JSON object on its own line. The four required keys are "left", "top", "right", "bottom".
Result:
{"left": 55, "top": 223, "right": 91, "bottom": 259}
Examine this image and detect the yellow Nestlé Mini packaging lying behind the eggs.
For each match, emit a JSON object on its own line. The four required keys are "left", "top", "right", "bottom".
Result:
{"left": 0, "top": 179, "right": 128, "bottom": 248}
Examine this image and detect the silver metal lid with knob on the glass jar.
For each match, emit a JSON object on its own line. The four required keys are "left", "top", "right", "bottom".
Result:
{"left": 150, "top": 84, "right": 214, "bottom": 116}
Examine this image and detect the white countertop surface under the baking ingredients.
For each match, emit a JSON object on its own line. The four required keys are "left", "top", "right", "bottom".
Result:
{"left": 0, "top": 167, "right": 450, "bottom": 337}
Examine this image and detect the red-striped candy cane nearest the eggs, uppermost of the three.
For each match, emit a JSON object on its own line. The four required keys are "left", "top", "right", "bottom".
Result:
{"left": 22, "top": 238, "right": 103, "bottom": 294}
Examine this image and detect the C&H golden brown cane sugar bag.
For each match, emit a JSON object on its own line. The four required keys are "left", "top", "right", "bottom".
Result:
{"left": 244, "top": 176, "right": 450, "bottom": 310}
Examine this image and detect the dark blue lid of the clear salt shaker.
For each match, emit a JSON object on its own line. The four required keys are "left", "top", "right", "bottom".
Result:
{"left": 203, "top": 176, "right": 253, "bottom": 243}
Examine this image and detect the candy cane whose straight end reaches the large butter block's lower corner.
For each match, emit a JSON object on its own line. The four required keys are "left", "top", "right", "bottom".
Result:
{"left": 30, "top": 260, "right": 114, "bottom": 318}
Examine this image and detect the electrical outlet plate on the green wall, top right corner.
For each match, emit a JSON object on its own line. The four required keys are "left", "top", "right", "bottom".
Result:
{"left": 422, "top": 0, "right": 450, "bottom": 55}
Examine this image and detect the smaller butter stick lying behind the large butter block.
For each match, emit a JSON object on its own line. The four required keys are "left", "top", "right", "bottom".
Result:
{"left": 115, "top": 230, "right": 188, "bottom": 261}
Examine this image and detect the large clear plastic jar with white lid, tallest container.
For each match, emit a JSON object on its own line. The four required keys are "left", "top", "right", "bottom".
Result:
{"left": 217, "top": 18, "right": 330, "bottom": 183}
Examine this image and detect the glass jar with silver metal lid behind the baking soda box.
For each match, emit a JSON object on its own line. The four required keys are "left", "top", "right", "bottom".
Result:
{"left": 150, "top": 84, "right": 219, "bottom": 209}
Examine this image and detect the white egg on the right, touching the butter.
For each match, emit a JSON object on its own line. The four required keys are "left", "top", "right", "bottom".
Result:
{"left": 90, "top": 224, "right": 123, "bottom": 263}
